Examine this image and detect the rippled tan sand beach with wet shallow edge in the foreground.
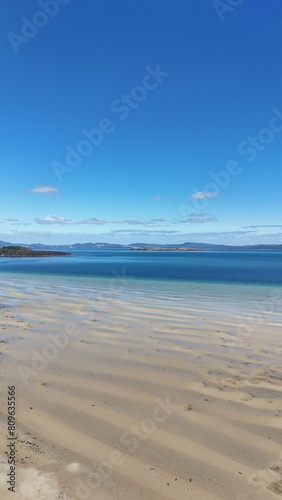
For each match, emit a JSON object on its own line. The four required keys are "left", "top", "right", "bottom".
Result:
{"left": 0, "top": 280, "right": 282, "bottom": 500}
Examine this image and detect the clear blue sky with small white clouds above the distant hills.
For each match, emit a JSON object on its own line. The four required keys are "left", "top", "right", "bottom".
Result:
{"left": 0, "top": 0, "right": 282, "bottom": 244}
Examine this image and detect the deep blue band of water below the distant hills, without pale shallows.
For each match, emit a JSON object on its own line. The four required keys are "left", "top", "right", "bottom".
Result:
{"left": 0, "top": 250, "right": 282, "bottom": 285}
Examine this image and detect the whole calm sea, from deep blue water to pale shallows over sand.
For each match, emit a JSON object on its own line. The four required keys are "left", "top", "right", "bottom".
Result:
{"left": 0, "top": 250, "right": 282, "bottom": 328}
